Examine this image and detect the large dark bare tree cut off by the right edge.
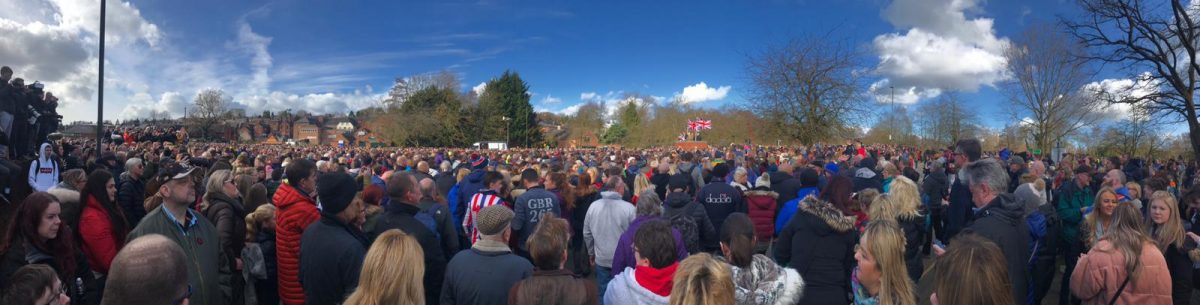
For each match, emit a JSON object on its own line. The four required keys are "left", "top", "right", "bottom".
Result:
{"left": 1063, "top": 0, "right": 1200, "bottom": 156}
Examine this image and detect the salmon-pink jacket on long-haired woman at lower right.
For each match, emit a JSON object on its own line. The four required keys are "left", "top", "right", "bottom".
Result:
{"left": 1070, "top": 240, "right": 1171, "bottom": 305}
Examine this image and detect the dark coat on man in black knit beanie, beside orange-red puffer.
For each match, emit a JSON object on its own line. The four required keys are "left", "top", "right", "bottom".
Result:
{"left": 300, "top": 214, "right": 368, "bottom": 304}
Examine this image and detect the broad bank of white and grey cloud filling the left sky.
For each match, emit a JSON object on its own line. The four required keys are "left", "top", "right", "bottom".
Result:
{"left": 0, "top": 0, "right": 393, "bottom": 121}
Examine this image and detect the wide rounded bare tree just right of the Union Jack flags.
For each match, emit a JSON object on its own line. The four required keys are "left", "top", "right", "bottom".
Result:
{"left": 746, "top": 35, "right": 868, "bottom": 144}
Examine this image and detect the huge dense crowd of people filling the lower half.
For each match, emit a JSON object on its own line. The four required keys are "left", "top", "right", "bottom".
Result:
{"left": 0, "top": 138, "right": 1200, "bottom": 305}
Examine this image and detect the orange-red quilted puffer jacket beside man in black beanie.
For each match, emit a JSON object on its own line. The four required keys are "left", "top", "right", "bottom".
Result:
{"left": 272, "top": 184, "right": 320, "bottom": 305}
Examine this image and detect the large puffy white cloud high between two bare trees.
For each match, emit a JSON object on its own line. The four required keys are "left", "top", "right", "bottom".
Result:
{"left": 874, "top": 0, "right": 1009, "bottom": 102}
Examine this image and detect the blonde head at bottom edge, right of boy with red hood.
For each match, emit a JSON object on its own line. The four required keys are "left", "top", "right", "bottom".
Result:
{"left": 670, "top": 253, "right": 733, "bottom": 305}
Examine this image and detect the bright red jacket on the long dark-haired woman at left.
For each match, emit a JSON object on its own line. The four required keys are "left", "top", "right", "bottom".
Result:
{"left": 79, "top": 196, "right": 130, "bottom": 274}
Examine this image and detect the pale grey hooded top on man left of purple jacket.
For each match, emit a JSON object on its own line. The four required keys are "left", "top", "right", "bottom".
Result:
{"left": 583, "top": 192, "right": 636, "bottom": 268}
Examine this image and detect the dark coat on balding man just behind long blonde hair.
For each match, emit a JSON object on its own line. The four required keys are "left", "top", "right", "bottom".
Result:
{"left": 370, "top": 202, "right": 452, "bottom": 304}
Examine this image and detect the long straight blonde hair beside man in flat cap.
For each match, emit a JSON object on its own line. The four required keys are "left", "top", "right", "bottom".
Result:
{"left": 343, "top": 229, "right": 425, "bottom": 305}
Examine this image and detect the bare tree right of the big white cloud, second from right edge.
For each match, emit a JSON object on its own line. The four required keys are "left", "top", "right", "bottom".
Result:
{"left": 1001, "top": 25, "right": 1104, "bottom": 150}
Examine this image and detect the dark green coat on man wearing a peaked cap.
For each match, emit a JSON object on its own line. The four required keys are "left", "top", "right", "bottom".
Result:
{"left": 126, "top": 205, "right": 228, "bottom": 305}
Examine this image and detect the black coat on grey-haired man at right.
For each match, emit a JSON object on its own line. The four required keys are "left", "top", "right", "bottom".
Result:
{"left": 952, "top": 193, "right": 1030, "bottom": 300}
